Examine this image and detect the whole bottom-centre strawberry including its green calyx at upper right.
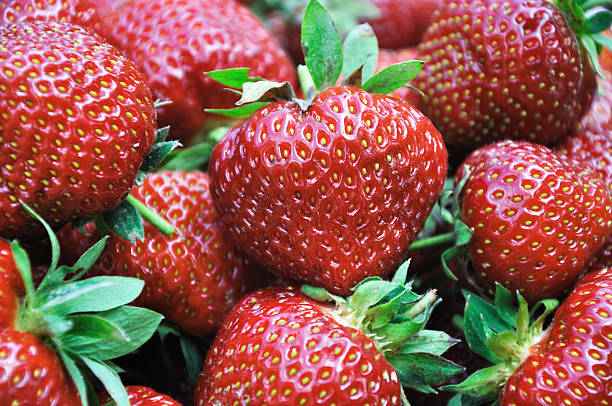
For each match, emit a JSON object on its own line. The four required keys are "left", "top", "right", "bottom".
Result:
{"left": 194, "top": 266, "right": 462, "bottom": 406}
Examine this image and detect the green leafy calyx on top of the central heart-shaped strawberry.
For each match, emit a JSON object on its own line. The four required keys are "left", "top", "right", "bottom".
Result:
{"left": 205, "top": 0, "right": 424, "bottom": 118}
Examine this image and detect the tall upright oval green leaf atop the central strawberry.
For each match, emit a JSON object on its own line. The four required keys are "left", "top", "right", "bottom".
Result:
{"left": 302, "top": 0, "right": 343, "bottom": 90}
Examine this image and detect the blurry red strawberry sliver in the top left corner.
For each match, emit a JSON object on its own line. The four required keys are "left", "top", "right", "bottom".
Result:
{"left": 0, "top": 0, "right": 104, "bottom": 31}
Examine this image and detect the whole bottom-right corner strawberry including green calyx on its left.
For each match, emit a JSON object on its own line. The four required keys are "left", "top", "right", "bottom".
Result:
{"left": 447, "top": 268, "right": 612, "bottom": 406}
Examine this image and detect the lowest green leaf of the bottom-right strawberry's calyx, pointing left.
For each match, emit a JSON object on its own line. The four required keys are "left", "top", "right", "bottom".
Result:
{"left": 442, "top": 363, "right": 512, "bottom": 397}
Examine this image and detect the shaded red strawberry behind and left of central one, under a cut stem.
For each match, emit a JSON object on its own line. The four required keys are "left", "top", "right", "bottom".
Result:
{"left": 60, "top": 172, "right": 261, "bottom": 336}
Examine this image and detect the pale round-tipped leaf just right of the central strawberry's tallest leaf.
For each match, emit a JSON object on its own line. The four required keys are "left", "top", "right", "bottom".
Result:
{"left": 342, "top": 24, "right": 378, "bottom": 81}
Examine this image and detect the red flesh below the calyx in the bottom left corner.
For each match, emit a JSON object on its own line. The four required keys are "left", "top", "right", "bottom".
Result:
{"left": 0, "top": 329, "right": 81, "bottom": 406}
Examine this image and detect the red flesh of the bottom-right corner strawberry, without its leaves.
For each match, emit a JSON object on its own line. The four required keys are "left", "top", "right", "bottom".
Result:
{"left": 500, "top": 268, "right": 612, "bottom": 406}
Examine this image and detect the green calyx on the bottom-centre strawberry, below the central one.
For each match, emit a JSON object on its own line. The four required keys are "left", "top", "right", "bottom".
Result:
{"left": 302, "top": 262, "right": 463, "bottom": 393}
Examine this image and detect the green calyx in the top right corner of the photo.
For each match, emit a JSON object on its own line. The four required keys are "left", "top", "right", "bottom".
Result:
{"left": 552, "top": 0, "right": 612, "bottom": 76}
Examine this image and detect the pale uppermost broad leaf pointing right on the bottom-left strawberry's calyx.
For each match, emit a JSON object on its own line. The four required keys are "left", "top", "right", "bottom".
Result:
{"left": 36, "top": 276, "right": 144, "bottom": 316}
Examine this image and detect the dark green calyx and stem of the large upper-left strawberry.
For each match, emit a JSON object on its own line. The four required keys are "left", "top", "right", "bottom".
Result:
{"left": 73, "top": 127, "right": 180, "bottom": 244}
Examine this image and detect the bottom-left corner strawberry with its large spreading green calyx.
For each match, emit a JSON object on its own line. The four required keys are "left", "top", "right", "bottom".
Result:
{"left": 0, "top": 207, "right": 162, "bottom": 406}
